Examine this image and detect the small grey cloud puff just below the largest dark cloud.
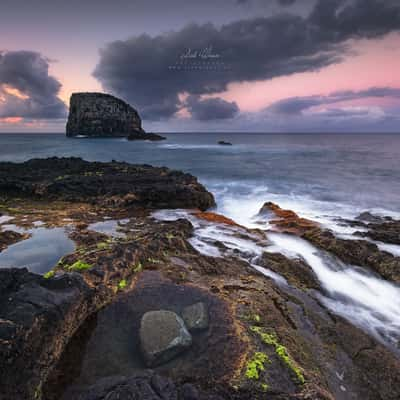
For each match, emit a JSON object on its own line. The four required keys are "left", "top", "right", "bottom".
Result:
{"left": 186, "top": 95, "right": 239, "bottom": 121}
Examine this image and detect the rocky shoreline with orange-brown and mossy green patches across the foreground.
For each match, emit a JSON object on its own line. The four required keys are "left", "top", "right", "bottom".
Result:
{"left": 0, "top": 158, "right": 400, "bottom": 400}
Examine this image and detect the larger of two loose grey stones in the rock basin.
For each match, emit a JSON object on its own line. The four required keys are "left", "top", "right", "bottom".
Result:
{"left": 140, "top": 310, "right": 192, "bottom": 367}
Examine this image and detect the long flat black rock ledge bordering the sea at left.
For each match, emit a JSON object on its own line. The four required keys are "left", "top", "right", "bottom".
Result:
{"left": 0, "top": 158, "right": 215, "bottom": 210}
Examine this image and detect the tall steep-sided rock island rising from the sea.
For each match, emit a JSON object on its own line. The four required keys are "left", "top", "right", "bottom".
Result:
{"left": 66, "top": 93, "right": 144, "bottom": 137}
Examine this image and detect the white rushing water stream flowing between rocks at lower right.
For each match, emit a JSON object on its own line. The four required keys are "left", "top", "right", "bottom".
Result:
{"left": 269, "top": 234, "right": 400, "bottom": 341}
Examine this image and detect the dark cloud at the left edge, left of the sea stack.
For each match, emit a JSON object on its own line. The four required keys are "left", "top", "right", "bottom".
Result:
{"left": 0, "top": 51, "right": 66, "bottom": 119}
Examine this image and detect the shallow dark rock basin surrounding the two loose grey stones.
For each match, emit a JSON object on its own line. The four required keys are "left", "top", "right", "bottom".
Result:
{"left": 44, "top": 272, "right": 242, "bottom": 400}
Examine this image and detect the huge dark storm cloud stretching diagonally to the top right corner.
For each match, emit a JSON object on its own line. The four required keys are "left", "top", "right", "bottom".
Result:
{"left": 94, "top": 0, "right": 400, "bottom": 119}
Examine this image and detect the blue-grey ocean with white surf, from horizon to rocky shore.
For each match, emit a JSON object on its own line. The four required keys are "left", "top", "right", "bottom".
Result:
{"left": 0, "top": 133, "right": 400, "bottom": 223}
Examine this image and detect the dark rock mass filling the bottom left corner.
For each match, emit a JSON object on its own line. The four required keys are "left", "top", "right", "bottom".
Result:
{"left": 0, "top": 269, "right": 110, "bottom": 400}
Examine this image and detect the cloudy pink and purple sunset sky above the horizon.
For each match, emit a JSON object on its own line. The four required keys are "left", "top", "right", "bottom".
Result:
{"left": 0, "top": 0, "right": 400, "bottom": 133}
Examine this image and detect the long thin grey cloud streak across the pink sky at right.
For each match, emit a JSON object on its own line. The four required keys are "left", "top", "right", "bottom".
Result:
{"left": 267, "top": 87, "right": 400, "bottom": 115}
